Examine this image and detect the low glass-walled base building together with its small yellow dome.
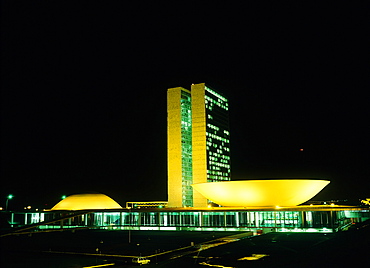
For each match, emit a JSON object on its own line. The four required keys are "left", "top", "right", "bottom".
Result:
{"left": 0, "top": 193, "right": 370, "bottom": 232}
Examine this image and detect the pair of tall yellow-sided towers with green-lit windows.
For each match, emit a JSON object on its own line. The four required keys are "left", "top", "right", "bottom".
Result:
{"left": 167, "top": 83, "right": 230, "bottom": 207}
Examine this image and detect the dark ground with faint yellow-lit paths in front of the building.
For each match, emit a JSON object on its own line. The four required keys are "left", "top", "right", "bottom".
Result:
{"left": 0, "top": 224, "right": 370, "bottom": 268}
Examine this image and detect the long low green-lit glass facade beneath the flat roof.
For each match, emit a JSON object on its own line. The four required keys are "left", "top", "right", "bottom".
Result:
{"left": 8, "top": 209, "right": 370, "bottom": 232}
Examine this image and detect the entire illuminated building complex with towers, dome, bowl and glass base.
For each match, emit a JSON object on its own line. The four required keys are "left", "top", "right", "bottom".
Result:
{"left": 4, "top": 84, "right": 370, "bottom": 235}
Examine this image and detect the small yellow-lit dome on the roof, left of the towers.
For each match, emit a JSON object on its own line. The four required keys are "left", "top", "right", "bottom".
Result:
{"left": 51, "top": 194, "right": 122, "bottom": 210}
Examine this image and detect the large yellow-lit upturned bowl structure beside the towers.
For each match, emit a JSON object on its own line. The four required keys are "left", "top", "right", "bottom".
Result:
{"left": 192, "top": 179, "right": 330, "bottom": 207}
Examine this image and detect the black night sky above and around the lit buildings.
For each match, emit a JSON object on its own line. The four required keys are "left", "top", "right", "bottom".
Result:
{"left": 0, "top": 1, "right": 370, "bottom": 207}
